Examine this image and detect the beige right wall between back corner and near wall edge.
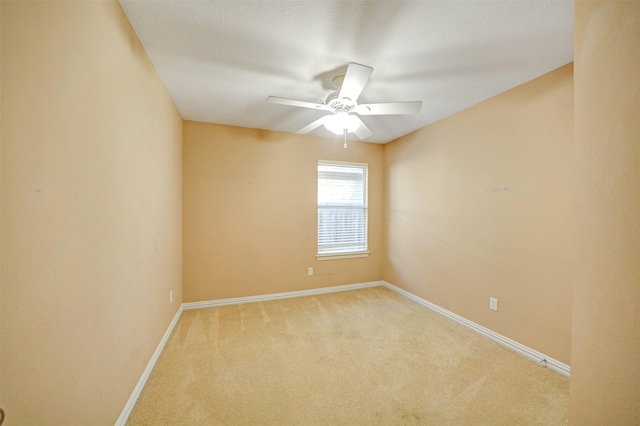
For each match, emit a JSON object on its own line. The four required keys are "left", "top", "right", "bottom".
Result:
{"left": 384, "top": 64, "right": 573, "bottom": 363}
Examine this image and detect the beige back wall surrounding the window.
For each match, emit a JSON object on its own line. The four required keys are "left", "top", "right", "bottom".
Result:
{"left": 183, "top": 121, "right": 383, "bottom": 302}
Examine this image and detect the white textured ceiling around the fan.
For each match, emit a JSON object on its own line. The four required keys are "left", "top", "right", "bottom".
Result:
{"left": 120, "top": 0, "right": 573, "bottom": 143}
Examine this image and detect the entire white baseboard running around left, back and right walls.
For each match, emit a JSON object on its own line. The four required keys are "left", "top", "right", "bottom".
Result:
{"left": 115, "top": 281, "right": 571, "bottom": 426}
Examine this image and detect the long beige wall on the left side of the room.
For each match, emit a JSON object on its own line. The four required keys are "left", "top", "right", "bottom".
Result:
{"left": 1, "top": 1, "right": 182, "bottom": 425}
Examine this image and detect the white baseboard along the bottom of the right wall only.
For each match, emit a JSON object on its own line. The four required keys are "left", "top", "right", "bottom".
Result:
{"left": 383, "top": 281, "right": 571, "bottom": 377}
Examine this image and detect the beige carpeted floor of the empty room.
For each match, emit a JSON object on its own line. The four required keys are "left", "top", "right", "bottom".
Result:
{"left": 128, "top": 287, "right": 569, "bottom": 425}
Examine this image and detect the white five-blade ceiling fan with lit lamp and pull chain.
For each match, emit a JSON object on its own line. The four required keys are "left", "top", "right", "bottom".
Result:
{"left": 267, "top": 62, "right": 422, "bottom": 148}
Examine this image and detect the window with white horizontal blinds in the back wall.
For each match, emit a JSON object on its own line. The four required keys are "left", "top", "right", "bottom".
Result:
{"left": 318, "top": 161, "right": 369, "bottom": 259}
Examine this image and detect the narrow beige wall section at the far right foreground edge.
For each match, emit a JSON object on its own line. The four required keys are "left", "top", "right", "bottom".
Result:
{"left": 569, "top": 1, "right": 640, "bottom": 425}
